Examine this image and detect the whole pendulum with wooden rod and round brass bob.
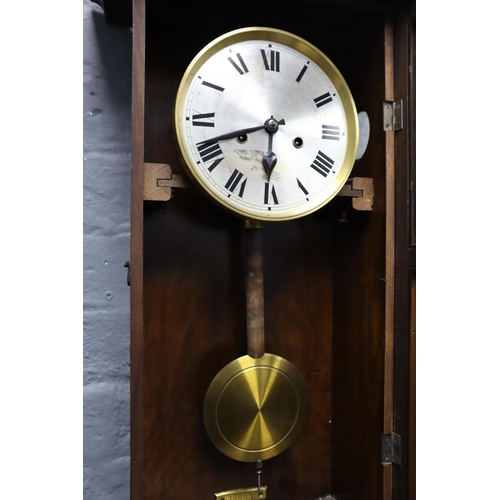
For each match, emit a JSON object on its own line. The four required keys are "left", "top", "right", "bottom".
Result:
{"left": 204, "top": 221, "right": 307, "bottom": 462}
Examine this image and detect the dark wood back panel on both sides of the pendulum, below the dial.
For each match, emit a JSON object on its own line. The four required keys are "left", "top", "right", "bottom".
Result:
{"left": 144, "top": 194, "right": 332, "bottom": 499}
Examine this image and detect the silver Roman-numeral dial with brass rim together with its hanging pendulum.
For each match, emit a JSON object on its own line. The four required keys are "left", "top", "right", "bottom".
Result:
{"left": 175, "top": 28, "right": 359, "bottom": 474}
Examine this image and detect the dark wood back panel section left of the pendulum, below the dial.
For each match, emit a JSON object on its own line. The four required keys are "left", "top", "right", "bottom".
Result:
{"left": 144, "top": 194, "right": 247, "bottom": 500}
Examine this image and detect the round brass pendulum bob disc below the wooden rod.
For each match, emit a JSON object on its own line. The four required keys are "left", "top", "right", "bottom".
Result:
{"left": 204, "top": 354, "right": 307, "bottom": 462}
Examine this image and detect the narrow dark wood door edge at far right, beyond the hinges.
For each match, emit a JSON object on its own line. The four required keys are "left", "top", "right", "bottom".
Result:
{"left": 393, "top": 0, "right": 416, "bottom": 499}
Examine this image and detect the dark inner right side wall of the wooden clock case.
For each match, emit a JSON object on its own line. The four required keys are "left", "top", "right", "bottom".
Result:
{"left": 332, "top": 7, "right": 392, "bottom": 500}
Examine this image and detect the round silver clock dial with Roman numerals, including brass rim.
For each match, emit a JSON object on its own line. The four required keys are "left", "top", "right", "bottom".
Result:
{"left": 175, "top": 28, "right": 358, "bottom": 220}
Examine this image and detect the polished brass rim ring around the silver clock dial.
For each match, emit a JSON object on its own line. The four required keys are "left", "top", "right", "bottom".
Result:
{"left": 174, "top": 27, "right": 359, "bottom": 221}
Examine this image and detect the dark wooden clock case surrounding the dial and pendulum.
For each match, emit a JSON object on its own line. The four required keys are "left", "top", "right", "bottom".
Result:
{"left": 130, "top": 0, "right": 415, "bottom": 500}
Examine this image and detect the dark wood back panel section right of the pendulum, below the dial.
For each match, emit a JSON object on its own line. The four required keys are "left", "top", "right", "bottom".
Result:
{"left": 264, "top": 214, "right": 333, "bottom": 499}
